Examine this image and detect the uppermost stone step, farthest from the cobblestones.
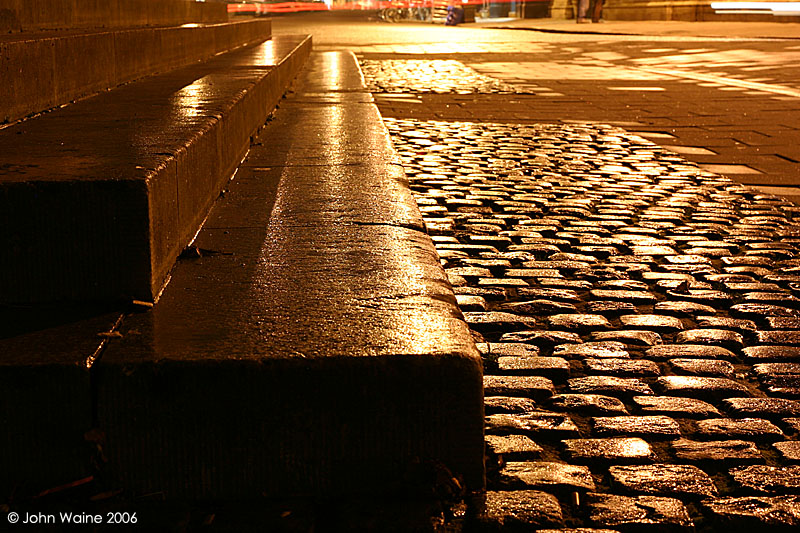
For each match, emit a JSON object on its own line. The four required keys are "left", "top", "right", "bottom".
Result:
{"left": 0, "top": 0, "right": 228, "bottom": 33}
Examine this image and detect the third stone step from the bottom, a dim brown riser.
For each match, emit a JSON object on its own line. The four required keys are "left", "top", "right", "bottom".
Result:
{"left": 0, "top": 19, "right": 271, "bottom": 123}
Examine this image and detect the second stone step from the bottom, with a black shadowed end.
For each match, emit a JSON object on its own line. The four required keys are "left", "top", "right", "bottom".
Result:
{"left": 0, "top": 35, "right": 311, "bottom": 303}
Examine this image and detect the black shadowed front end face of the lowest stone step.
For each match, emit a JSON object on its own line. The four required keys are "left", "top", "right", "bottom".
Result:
{"left": 98, "top": 356, "right": 483, "bottom": 501}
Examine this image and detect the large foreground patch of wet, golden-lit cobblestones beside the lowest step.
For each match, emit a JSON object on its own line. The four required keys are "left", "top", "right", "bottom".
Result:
{"left": 385, "top": 115, "right": 800, "bottom": 531}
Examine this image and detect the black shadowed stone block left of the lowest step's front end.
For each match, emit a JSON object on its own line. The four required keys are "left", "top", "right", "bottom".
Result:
{"left": 0, "top": 308, "right": 119, "bottom": 501}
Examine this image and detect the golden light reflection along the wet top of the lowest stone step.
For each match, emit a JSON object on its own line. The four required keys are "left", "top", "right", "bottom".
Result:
{"left": 247, "top": 52, "right": 470, "bottom": 356}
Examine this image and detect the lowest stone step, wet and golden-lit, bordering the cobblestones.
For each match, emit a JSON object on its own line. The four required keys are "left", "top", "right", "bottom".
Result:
{"left": 94, "top": 48, "right": 483, "bottom": 500}
